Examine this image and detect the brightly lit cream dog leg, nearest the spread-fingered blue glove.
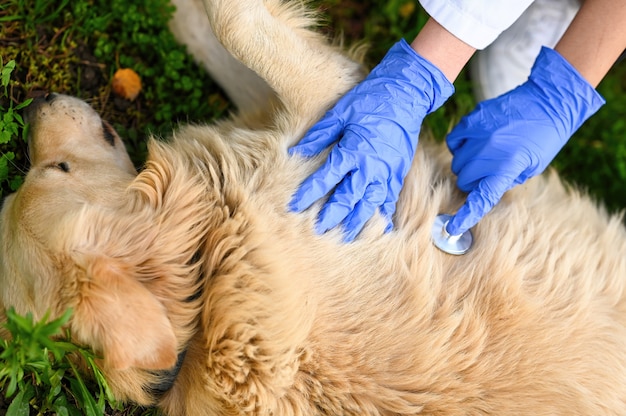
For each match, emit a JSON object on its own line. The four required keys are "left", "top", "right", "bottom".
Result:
{"left": 204, "top": 0, "right": 363, "bottom": 127}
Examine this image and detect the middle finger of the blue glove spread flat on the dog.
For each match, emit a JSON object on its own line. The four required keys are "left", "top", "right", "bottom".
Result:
{"left": 315, "top": 170, "right": 371, "bottom": 234}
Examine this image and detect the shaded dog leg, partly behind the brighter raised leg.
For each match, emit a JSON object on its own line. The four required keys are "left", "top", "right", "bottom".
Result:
{"left": 170, "top": 0, "right": 274, "bottom": 112}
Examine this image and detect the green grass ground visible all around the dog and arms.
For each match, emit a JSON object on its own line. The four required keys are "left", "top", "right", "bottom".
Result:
{"left": 0, "top": 0, "right": 626, "bottom": 415}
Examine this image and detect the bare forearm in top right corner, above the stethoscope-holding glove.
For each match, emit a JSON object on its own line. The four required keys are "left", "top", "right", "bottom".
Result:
{"left": 555, "top": 0, "right": 626, "bottom": 87}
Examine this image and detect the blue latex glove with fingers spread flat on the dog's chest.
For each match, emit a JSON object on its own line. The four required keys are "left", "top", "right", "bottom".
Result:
{"left": 289, "top": 40, "right": 454, "bottom": 241}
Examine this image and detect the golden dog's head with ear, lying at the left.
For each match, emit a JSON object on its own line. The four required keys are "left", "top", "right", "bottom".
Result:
{"left": 0, "top": 94, "right": 176, "bottom": 368}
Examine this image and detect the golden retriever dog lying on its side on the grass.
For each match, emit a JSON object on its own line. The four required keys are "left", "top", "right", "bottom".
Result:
{"left": 0, "top": 0, "right": 626, "bottom": 416}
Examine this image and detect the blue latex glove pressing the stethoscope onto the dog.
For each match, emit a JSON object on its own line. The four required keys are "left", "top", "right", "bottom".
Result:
{"left": 446, "top": 47, "right": 604, "bottom": 235}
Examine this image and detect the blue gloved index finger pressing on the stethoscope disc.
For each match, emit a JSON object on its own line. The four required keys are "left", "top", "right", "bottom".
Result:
{"left": 446, "top": 176, "right": 514, "bottom": 235}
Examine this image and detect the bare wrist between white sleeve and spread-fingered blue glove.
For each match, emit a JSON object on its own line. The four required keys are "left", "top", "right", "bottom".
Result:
{"left": 411, "top": 18, "right": 476, "bottom": 82}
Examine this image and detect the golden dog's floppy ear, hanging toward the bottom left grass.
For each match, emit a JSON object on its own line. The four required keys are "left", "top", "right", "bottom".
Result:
{"left": 71, "top": 257, "right": 177, "bottom": 370}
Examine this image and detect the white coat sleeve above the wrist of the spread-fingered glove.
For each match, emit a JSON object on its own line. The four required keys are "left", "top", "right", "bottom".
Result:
{"left": 420, "top": 0, "right": 533, "bottom": 49}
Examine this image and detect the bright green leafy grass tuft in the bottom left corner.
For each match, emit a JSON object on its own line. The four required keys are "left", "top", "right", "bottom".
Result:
{"left": 0, "top": 309, "right": 118, "bottom": 416}
